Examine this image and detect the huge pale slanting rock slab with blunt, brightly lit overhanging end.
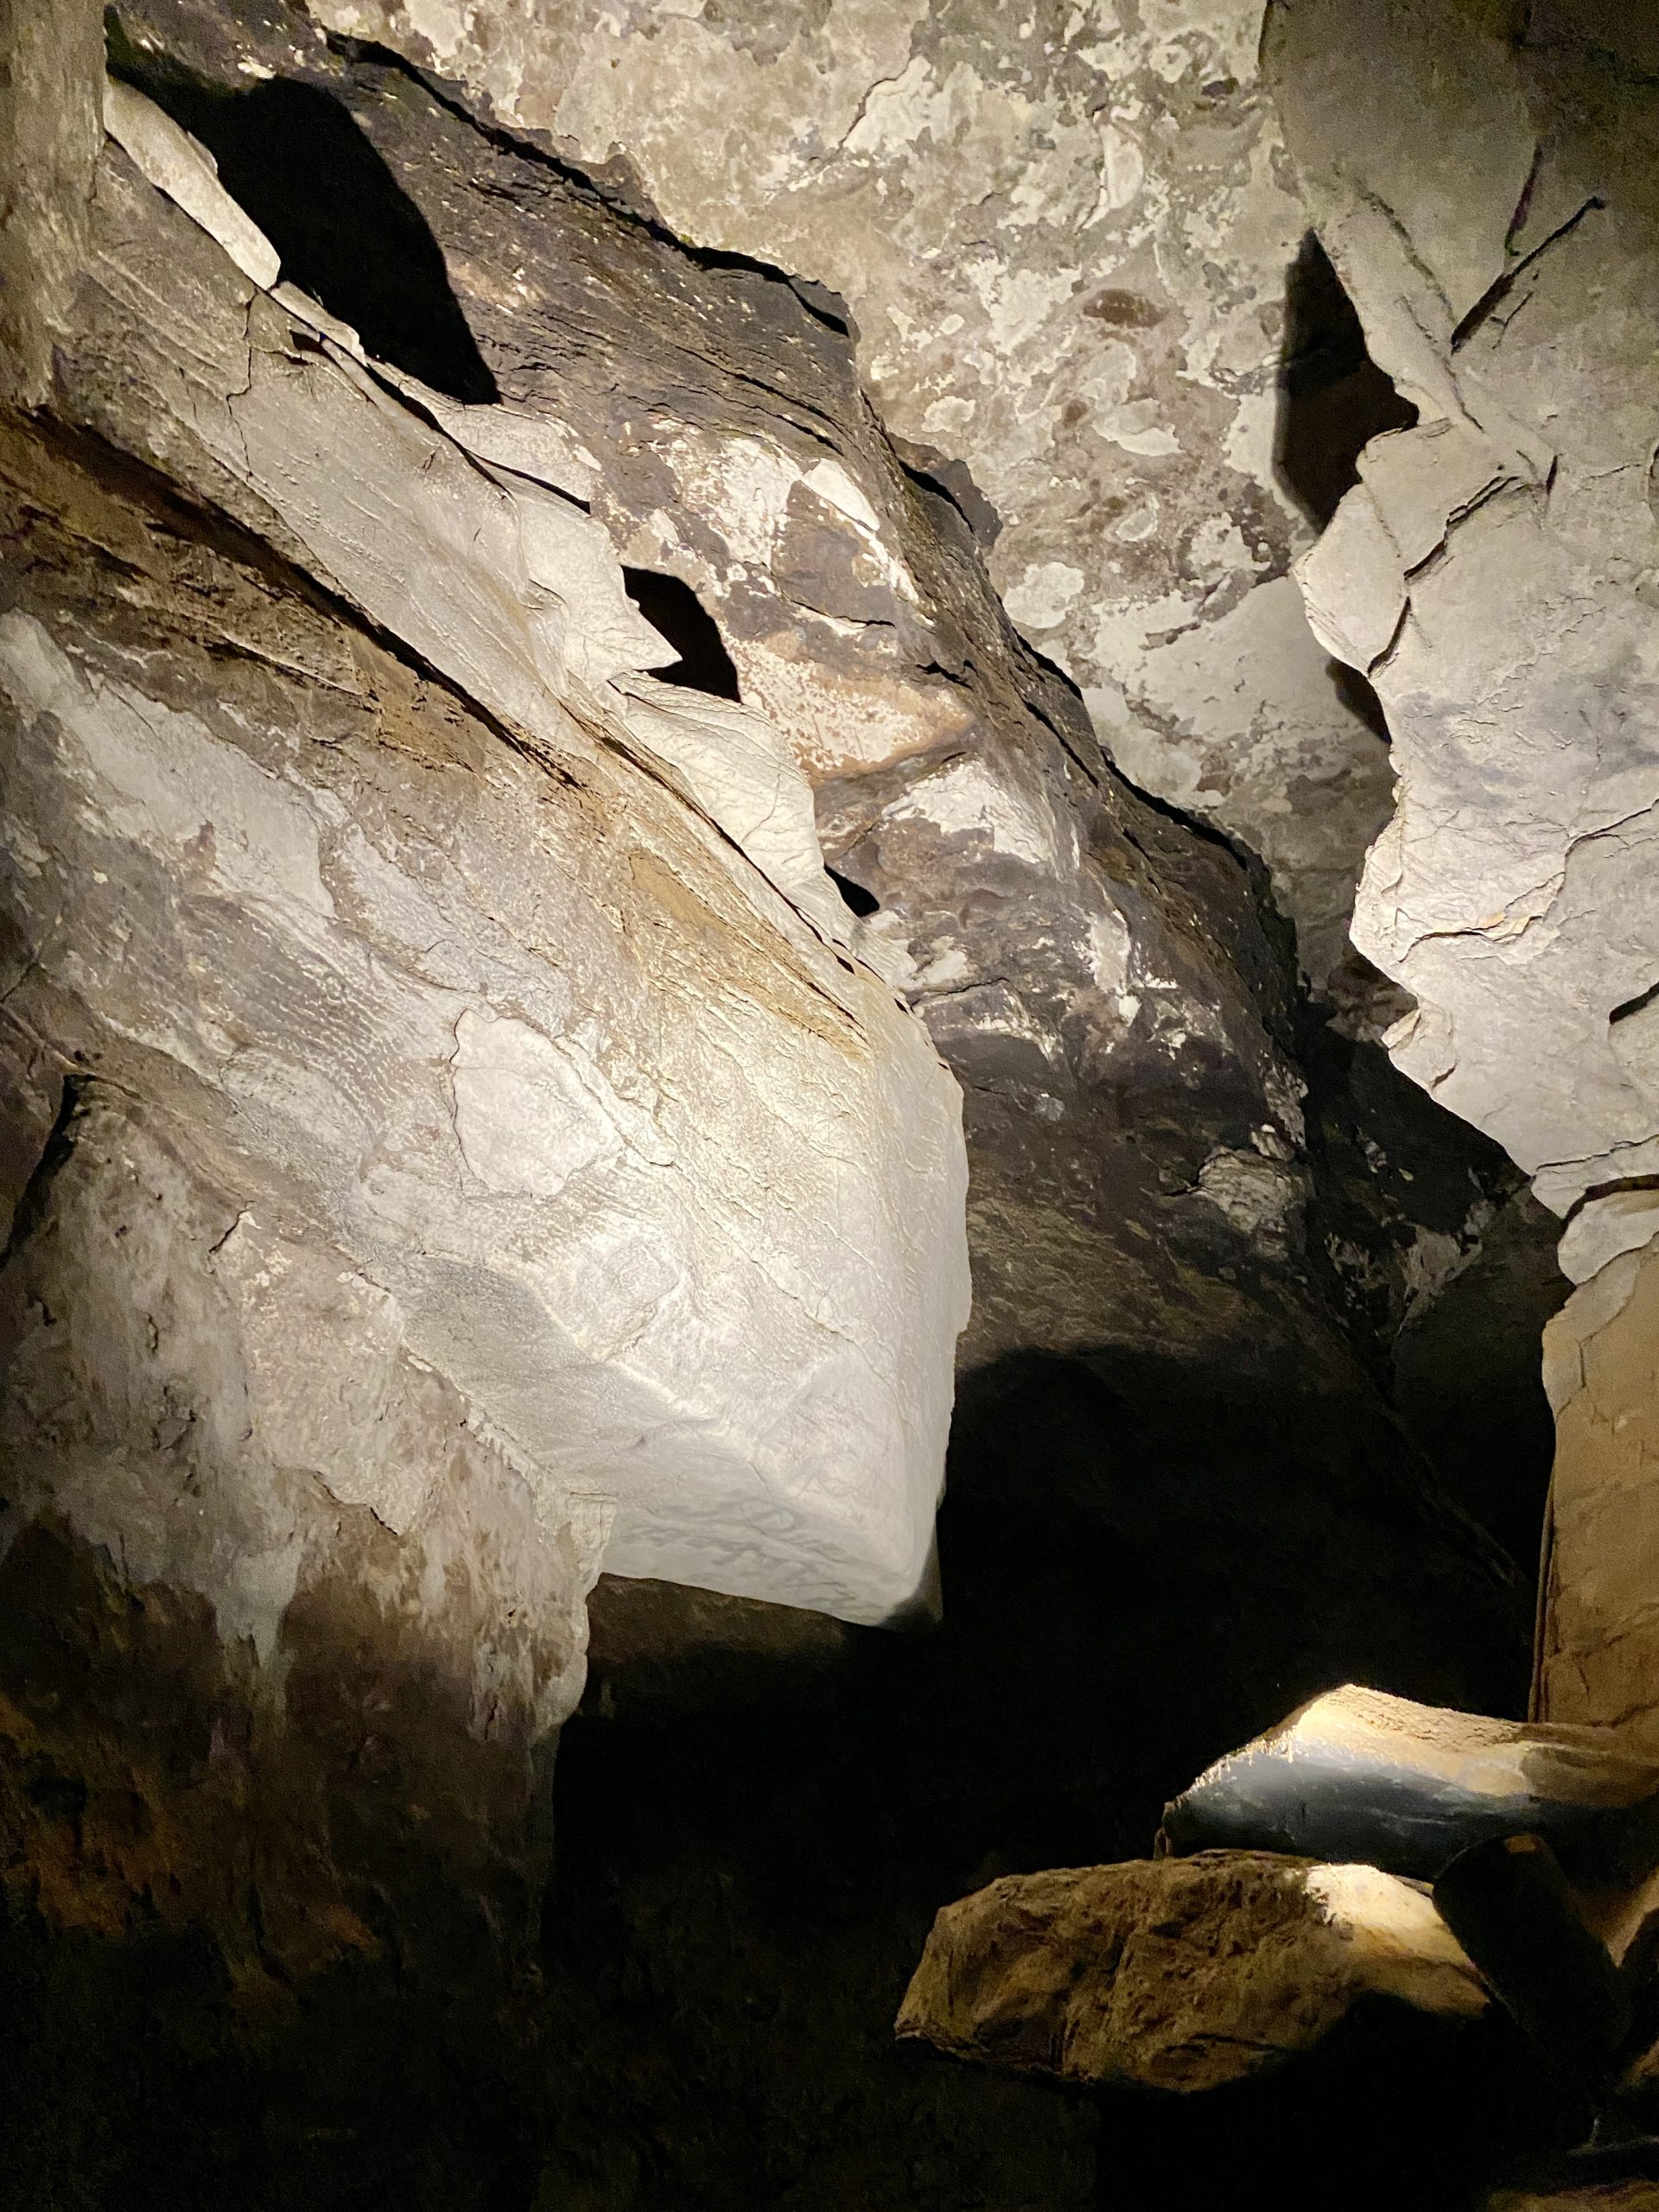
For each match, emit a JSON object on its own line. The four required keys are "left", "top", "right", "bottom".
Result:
{"left": 0, "top": 64, "right": 967, "bottom": 1617}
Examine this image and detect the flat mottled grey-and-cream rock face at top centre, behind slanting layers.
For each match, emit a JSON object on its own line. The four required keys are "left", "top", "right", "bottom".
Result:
{"left": 315, "top": 0, "right": 1389, "bottom": 982}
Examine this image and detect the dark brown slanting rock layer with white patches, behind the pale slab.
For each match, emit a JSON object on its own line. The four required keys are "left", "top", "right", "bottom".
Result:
{"left": 107, "top": 0, "right": 1343, "bottom": 1365}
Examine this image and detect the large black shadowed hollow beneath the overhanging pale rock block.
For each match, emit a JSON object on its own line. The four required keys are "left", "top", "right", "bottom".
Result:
{"left": 542, "top": 1347, "right": 1531, "bottom": 2212}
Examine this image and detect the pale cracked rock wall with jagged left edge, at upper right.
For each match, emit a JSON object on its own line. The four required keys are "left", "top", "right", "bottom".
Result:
{"left": 1265, "top": 0, "right": 1659, "bottom": 1212}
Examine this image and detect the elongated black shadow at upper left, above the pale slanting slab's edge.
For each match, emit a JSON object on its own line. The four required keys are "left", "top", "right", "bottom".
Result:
{"left": 111, "top": 22, "right": 500, "bottom": 403}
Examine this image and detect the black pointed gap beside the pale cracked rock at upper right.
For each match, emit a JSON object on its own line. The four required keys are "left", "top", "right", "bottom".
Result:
{"left": 1274, "top": 230, "right": 1418, "bottom": 529}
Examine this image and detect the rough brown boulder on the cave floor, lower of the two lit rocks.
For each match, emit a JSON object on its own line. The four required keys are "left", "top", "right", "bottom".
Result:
{"left": 898, "top": 1852, "right": 1486, "bottom": 2093}
